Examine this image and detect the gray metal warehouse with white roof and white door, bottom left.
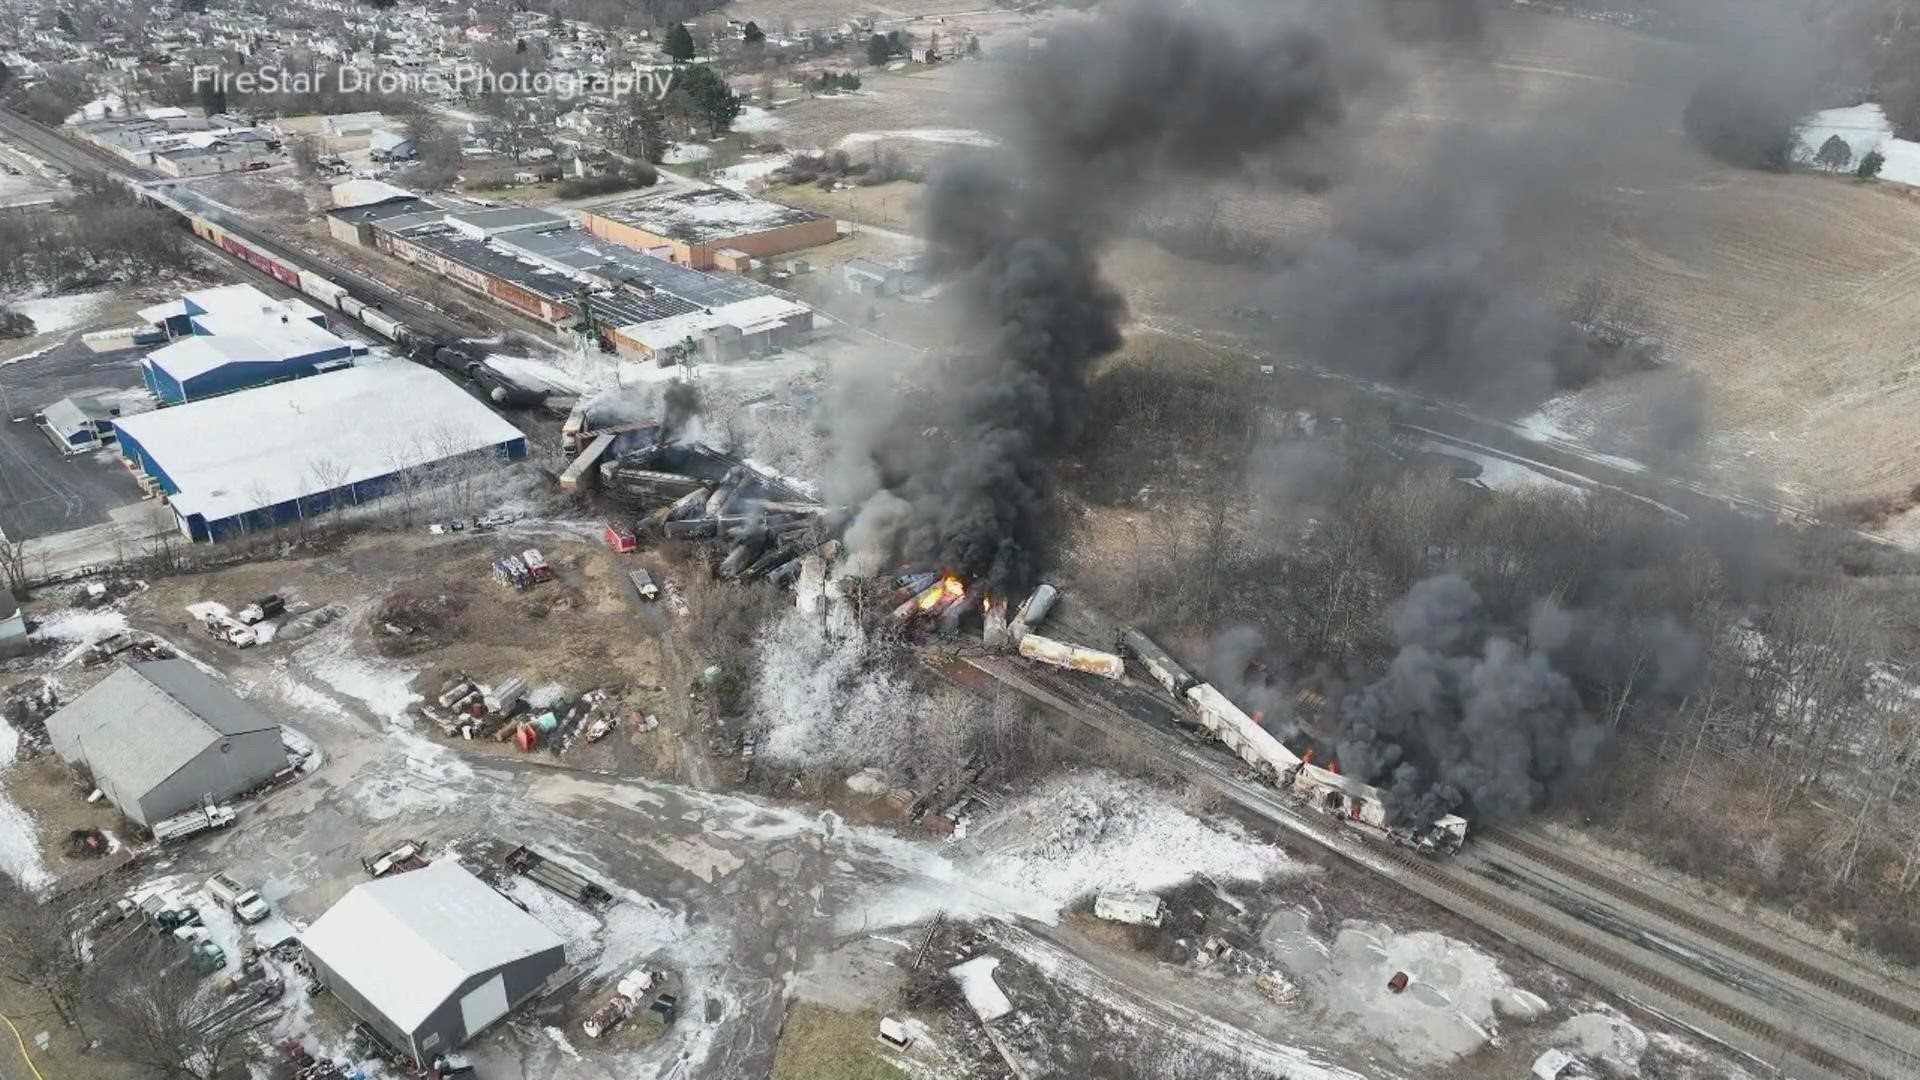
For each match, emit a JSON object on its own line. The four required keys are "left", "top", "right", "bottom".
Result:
{"left": 300, "top": 861, "right": 566, "bottom": 1065}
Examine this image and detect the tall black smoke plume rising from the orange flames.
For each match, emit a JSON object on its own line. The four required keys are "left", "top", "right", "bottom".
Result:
{"left": 843, "top": 4, "right": 1405, "bottom": 586}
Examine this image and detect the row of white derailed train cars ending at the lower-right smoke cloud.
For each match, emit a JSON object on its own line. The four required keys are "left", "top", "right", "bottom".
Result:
{"left": 1119, "top": 626, "right": 1467, "bottom": 855}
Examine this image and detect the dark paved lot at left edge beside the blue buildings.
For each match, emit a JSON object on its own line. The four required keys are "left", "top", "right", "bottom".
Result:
{"left": 0, "top": 338, "right": 151, "bottom": 540}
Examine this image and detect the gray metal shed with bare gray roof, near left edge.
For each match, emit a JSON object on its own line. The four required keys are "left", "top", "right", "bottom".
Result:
{"left": 46, "top": 659, "right": 286, "bottom": 826}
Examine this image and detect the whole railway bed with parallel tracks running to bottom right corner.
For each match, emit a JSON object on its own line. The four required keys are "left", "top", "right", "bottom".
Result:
{"left": 929, "top": 653, "right": 1920, "bottom": 1080}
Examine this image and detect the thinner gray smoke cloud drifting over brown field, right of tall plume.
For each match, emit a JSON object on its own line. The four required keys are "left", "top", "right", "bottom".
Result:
{"left": 1265, "top": 108, "right": 1688, "bottom": 417}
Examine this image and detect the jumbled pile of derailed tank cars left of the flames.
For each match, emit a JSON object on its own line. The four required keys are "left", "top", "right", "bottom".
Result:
{"left": 601, "top": 442, "right": 849, "bottom": 584}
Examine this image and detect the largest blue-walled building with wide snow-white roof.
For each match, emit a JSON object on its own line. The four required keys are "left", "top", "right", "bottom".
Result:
{"left": 117, "top": 359, "right": 526, "bottom": 540}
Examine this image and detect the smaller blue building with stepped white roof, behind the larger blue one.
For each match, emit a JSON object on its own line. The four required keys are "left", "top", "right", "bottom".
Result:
{"left": 140, "top": 284, "right": 367, "bottom": 405}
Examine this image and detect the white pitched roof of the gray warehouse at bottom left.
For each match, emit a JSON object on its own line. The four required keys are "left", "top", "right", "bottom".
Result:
{"left": 300, "top": 861, "right": 564, "bottom": 1032}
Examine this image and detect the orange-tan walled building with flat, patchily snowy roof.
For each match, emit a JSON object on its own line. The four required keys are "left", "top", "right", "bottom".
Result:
{"left": 580, "top": 184, "right": 839, "bottom": 271}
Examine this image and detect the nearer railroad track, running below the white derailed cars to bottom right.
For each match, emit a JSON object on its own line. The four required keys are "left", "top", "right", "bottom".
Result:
{"left": 929, "top": 655, "right": 1907, "bottom": 1080}
